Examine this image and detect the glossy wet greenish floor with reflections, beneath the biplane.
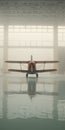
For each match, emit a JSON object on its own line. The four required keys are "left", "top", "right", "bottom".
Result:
{"left": 0, "top": 74, "right": 65, "bottom": 130}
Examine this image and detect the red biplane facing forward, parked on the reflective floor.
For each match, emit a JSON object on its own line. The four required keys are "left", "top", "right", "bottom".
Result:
{"left": 5, "top": 55, "right": 58, "bottom": 77}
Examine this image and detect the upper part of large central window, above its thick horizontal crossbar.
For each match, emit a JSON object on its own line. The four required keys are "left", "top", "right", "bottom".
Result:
{"left": 8, "top": 26, "right": 53, "bottom": 47}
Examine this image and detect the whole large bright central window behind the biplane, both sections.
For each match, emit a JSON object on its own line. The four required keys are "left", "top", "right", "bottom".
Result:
{"left": 8, "top": 25, "right": 54, "bottom": 68}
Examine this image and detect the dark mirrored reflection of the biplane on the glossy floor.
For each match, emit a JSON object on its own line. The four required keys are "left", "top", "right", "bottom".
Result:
{"left": 5, "top": 77, "right": 58, "bottom": 98}
